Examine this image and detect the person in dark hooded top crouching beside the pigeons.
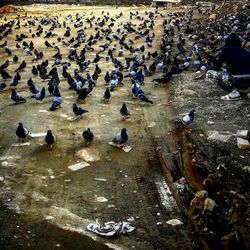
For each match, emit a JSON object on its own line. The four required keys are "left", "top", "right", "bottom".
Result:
{"left": 207, "top": 33, "right": 250, "bottom": 101}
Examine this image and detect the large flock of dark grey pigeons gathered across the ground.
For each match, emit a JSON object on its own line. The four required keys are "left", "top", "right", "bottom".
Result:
{"left": 0, "top": 3, "right": 247, "bottom": 148}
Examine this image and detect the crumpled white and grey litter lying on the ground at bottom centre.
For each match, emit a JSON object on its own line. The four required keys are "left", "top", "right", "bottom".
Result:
{"left": 87, "top": 221, "right": 135, "bottom": 237}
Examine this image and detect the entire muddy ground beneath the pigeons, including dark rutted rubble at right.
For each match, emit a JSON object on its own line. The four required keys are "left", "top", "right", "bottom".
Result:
{"left": 0, "top": 5, "right": 250, "bottom": 249}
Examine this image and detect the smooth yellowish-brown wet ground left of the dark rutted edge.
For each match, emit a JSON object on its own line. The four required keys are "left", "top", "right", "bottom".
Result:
{"left": 0, "top": 5, "right": 199, "bottom": 249}
